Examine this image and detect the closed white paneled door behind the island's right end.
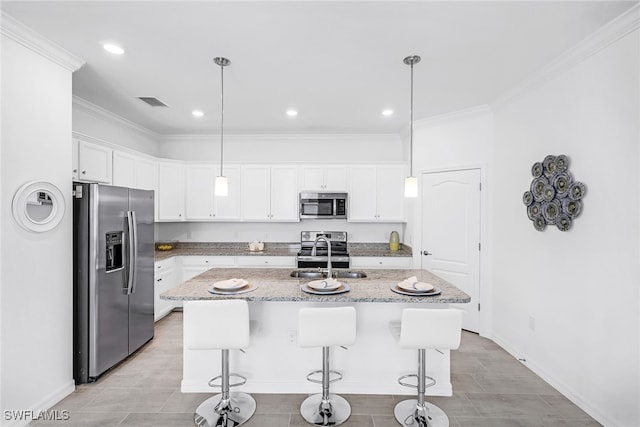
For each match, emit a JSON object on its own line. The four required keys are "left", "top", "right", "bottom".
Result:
{"left": 421, "top": 169, "right": 480, "bottom": 332}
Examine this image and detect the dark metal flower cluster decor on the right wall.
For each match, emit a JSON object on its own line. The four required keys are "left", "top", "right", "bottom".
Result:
{"left": 522, "top": 154, "right": 586, "bottom": 231}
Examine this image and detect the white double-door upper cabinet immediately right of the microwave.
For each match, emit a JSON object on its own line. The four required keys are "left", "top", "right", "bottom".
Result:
{"left": 349, "top": 165, "right": 406, "bottom": 222}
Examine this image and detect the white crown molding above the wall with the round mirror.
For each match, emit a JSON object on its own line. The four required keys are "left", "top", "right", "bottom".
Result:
{"left": 0, "top": 11, "right": 85, "bottom": 72}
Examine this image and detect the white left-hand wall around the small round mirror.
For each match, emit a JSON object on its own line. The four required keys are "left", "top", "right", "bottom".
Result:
{"left": 0, "top": 30, "right": 74, "bottom": 424}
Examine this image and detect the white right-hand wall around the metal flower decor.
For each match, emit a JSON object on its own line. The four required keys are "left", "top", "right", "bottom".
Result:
{"left": 490, "top": 27, "right": 640, "bottom": 427}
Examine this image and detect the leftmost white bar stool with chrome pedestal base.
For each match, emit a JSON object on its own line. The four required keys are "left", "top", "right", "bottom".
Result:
{"left": 183, "top": 300, "right": 256, "bottom": 427}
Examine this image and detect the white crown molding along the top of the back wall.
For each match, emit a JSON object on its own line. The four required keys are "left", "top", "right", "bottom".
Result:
{"left": 160, "top": 134, "right": 399, "bottom": 142}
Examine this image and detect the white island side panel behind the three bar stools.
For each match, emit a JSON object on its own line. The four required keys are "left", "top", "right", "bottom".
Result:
{"left": 181, "top": 301, "right": 452, "bottom": 396}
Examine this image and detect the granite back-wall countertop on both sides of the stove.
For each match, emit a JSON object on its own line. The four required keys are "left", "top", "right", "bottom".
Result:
{"left": 155, "top": 242, "right": 412, "bottom": 261}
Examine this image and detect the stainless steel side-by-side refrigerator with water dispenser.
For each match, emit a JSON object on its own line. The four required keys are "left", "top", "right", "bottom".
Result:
{"left": 73, "top": 182, "right": 154, "bottom": 384}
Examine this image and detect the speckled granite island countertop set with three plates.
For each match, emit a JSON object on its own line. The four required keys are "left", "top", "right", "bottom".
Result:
{"left": 160, "top": 268, "right": 471, "bottom": 303}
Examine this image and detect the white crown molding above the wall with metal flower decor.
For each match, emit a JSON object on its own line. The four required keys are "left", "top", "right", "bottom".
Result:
{"left": 489, "top": 4, "right": 640, "bottom": 109}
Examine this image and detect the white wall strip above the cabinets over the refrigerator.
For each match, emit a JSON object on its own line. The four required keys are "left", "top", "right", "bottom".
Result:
{"left": 73, "top": 97, "right": 160, "bottom": 156}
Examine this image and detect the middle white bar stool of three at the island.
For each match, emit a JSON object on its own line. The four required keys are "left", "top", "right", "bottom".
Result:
{"left": 298, "top": 307, "right": 356, "bottom": 426}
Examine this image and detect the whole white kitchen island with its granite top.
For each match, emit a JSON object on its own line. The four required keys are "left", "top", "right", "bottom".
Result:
{"left": 161, "top": 268, "right": 470, "bottom": 396}
